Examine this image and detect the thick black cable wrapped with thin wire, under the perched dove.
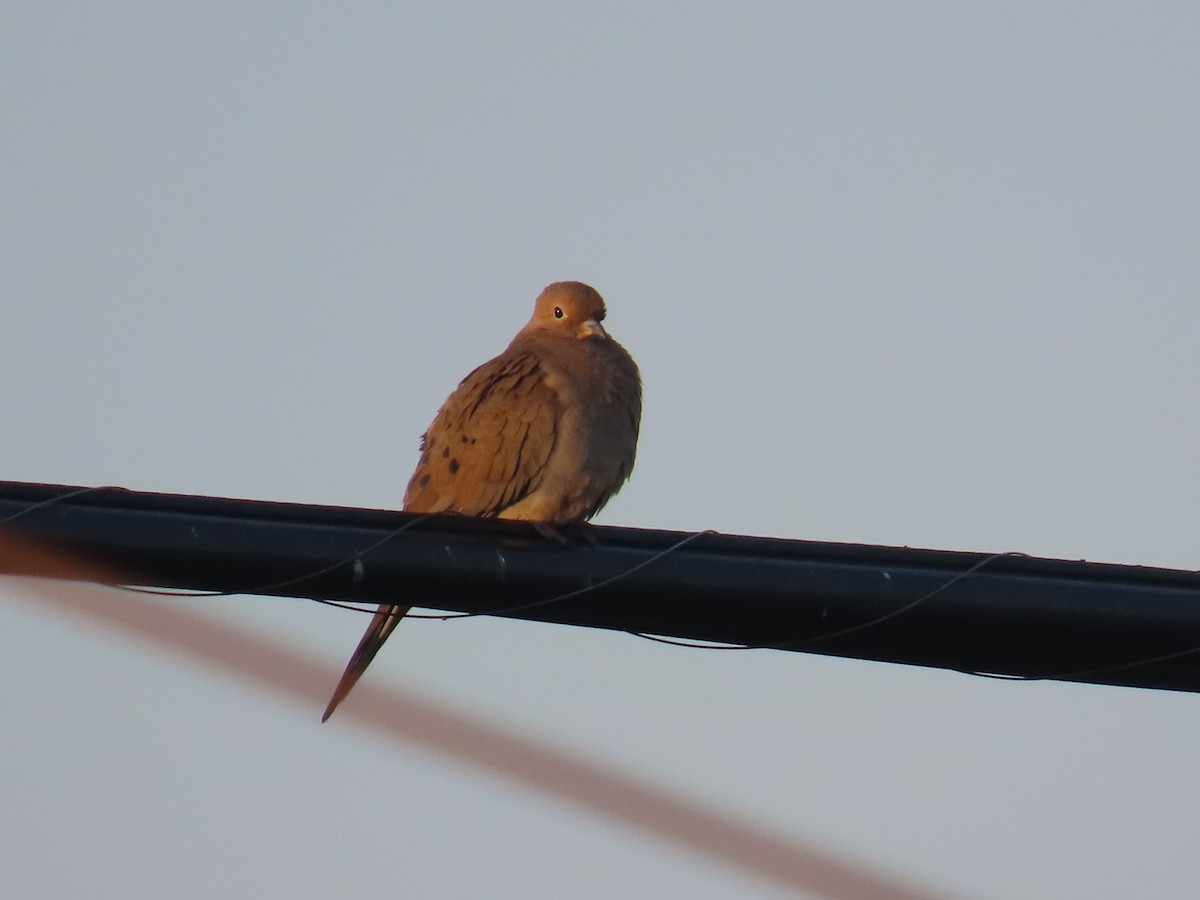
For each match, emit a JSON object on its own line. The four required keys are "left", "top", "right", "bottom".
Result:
{"left": 7, "top": 482, "right": 1200, "bottom": 691}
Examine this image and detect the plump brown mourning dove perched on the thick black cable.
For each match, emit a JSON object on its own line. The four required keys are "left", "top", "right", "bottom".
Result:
{"left": 322, "top": 281, "right": 642, "bottom": 721}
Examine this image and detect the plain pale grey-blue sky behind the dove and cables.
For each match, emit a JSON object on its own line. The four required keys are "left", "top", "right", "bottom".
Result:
{"left": 0, "top": 0, "right": 1200, "bottom": 900}
